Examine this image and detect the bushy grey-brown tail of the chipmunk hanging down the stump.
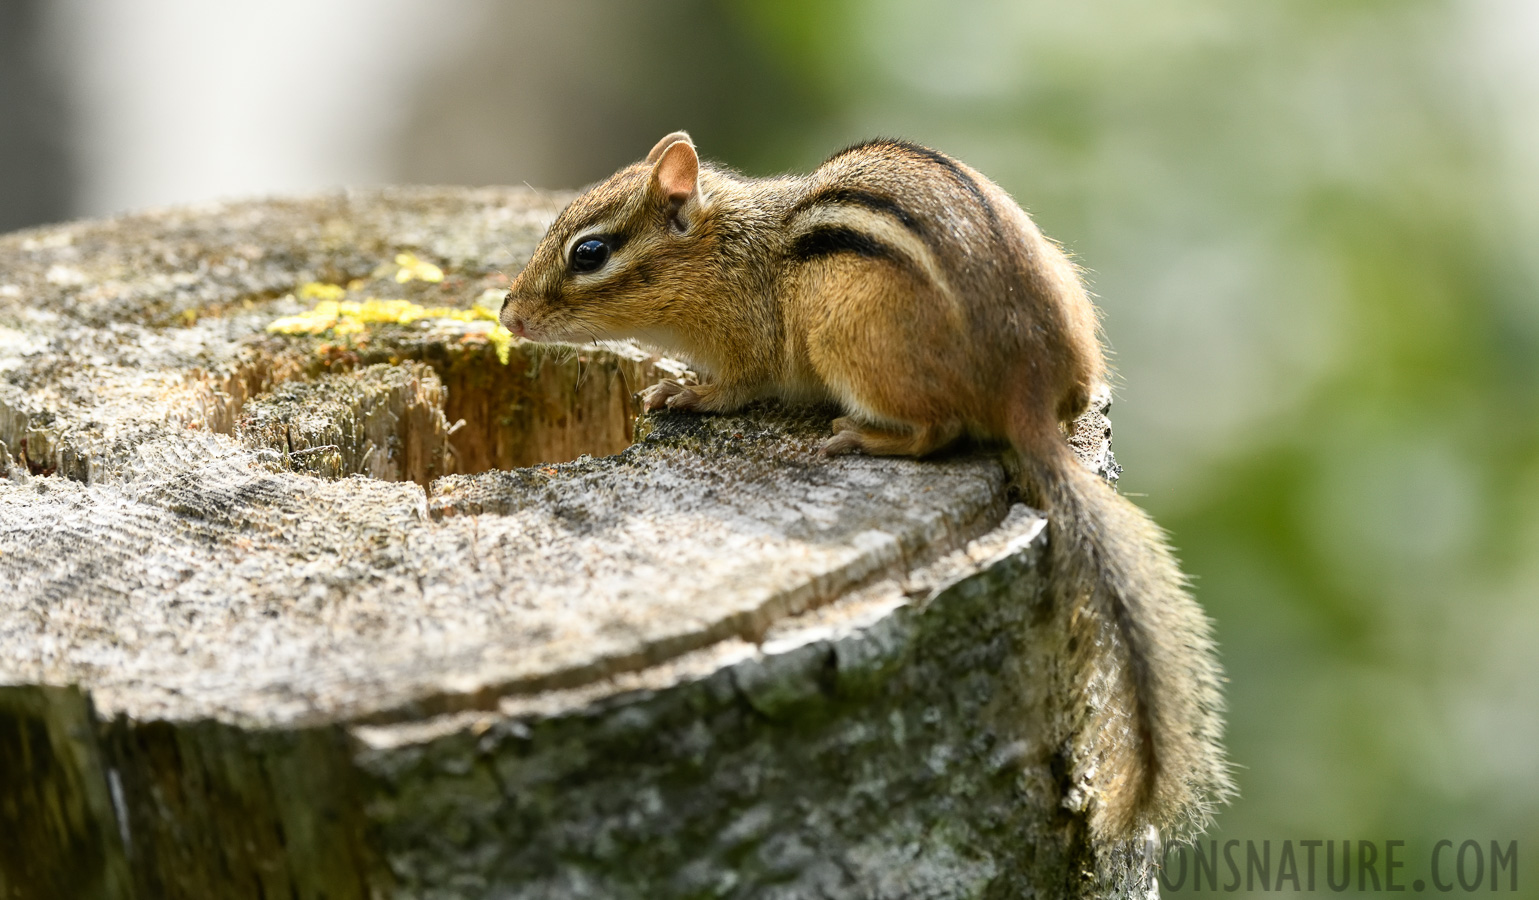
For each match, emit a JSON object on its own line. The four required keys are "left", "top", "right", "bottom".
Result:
{"left": 1016, "top": 429, "right": 1233, "bottom": 840}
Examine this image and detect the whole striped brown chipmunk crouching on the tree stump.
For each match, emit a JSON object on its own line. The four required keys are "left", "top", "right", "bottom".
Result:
{"left": 500, "top": 131, "right": 1231, "bottom": 840}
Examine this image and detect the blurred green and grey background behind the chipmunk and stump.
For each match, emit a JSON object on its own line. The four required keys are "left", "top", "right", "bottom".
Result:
{"left": 6, "top": 0, "right": 1539, "bottom": 894}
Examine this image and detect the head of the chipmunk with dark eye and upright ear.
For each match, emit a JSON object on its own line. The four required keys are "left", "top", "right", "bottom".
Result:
{"left": 500, "top": 131, "right": 711, "bottom": 345}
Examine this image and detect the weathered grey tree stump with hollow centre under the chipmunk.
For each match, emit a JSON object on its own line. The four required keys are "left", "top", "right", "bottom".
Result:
{"left": 0, "top": 189, "right": 1151, "bottom": 898}
